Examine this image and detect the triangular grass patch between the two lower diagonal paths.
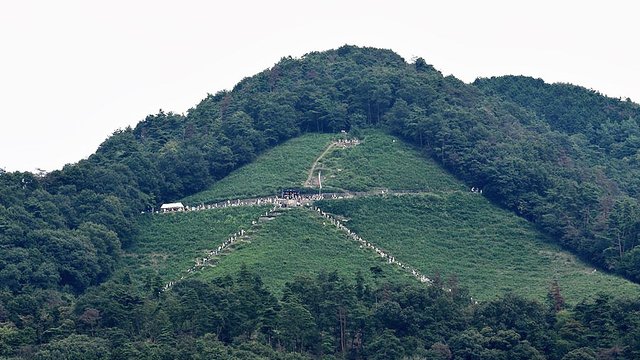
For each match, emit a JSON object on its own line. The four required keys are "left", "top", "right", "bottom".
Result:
{"left": 199, "top": 208, "right": 418, "bottom": 293}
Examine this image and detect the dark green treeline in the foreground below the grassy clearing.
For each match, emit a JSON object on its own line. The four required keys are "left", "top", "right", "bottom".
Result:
{"left": 0, "top": 268, "right": 640, "bottom": 360}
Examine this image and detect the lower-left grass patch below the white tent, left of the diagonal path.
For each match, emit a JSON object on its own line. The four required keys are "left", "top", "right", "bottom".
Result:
{"left": 123, "top": 206, "right": 268, "bottom": 282}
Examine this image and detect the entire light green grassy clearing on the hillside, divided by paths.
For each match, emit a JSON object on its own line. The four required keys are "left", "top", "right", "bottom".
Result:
{"left": 128, "top": 131, "right": 640, "bottom": 303}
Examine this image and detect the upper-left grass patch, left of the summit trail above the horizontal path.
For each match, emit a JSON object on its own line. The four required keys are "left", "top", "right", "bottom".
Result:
{"left": 183, "top": 134, "right": 336, "bottom": 205}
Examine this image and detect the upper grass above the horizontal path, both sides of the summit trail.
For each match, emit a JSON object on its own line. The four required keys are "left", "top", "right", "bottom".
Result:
{"left": 183, "top": 131, "right": 465, "bottom": 204}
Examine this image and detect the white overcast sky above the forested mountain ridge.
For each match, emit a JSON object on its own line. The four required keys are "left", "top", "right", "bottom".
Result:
{"left": 0, "top": 0, "right": 640, "bottom": 171}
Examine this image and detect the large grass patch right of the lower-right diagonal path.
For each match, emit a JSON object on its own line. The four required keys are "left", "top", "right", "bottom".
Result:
{"left": 319, "top": 192, "right": 640, "bottom": 304}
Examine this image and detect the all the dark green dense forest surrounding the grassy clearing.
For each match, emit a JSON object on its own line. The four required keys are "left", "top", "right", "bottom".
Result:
{"left": 0, "top": 46, "right": 640, "bottom": 359}
